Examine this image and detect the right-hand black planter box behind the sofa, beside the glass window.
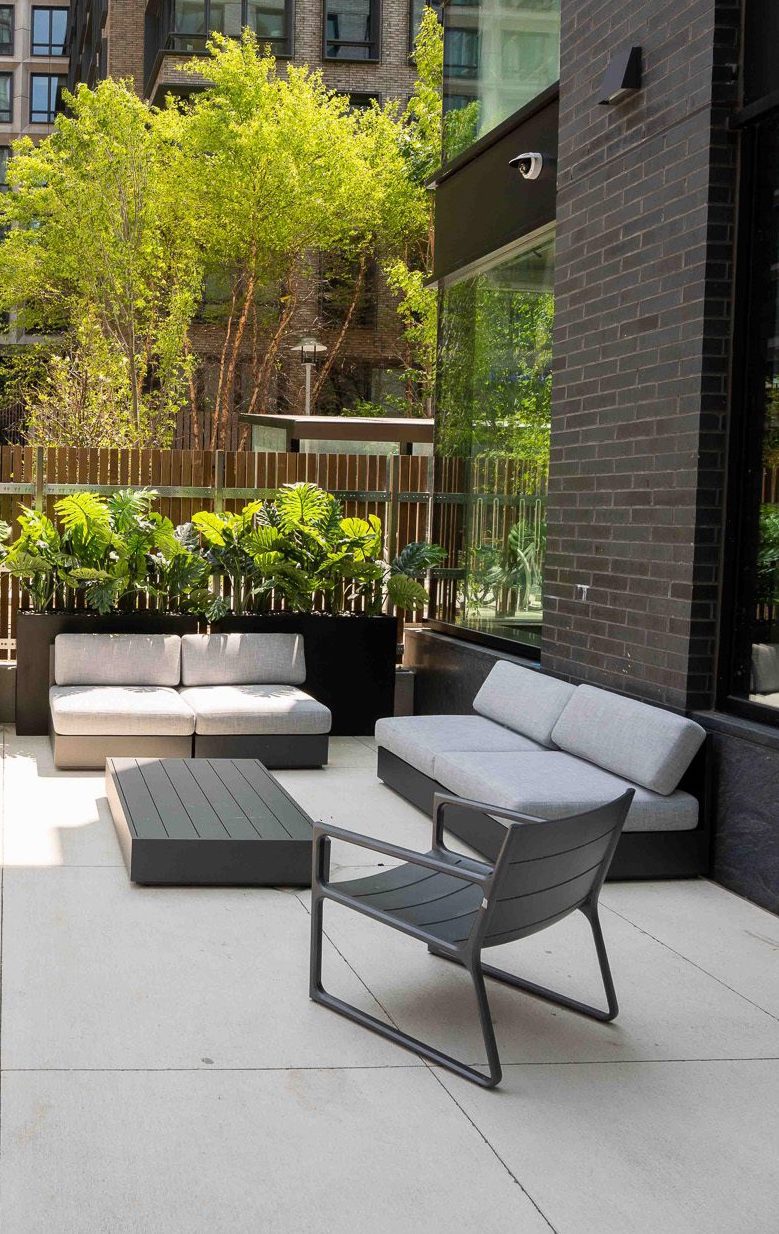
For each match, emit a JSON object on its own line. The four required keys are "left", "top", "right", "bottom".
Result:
{"left": 214, "top": 613, "right": 398, "bottom": 737}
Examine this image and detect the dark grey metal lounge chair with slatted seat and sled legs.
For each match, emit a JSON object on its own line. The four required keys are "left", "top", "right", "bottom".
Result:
{"left": 310, "top": 790, "right": 633, "bottom": 1088}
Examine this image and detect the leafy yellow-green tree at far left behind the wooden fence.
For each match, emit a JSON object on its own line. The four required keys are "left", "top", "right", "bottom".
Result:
{"left": 0, "top": 80, "right": 201, "bottom": 444}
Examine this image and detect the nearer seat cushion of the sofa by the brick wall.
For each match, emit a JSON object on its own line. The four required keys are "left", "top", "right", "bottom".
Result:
{"left": 433, "top": 750, "right": 698, "bottom": 832}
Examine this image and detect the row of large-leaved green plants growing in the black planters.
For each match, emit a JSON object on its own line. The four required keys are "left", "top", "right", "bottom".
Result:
{"left": 0, "top": 482, "right": 443, "bottom": 621}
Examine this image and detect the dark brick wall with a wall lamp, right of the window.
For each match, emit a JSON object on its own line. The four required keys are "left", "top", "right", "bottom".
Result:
{"left": 542, "top": 0, "right": 738, "bottom": 708}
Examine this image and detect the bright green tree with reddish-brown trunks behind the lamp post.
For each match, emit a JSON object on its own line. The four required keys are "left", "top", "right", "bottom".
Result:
{"left": 183, "top": 31, "right": 414, "bottom": 445}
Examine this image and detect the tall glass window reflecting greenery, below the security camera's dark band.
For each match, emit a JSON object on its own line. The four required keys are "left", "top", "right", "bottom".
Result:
{"left": 436, "top": 234, "right": 554, "bottom": 647}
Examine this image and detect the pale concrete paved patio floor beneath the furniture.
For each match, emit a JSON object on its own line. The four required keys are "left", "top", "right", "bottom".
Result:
{"left": 0, "top": 731, "right": 779, "bottom": 1234}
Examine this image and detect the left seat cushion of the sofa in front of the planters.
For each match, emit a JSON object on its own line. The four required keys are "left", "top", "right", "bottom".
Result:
{"left": 49, "top": 686, "right": 195, "bottom": 737}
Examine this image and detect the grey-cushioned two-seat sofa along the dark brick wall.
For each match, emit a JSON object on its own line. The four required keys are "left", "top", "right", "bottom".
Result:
{"left": 375, "top": 660, "right": 707, "bottom": 877}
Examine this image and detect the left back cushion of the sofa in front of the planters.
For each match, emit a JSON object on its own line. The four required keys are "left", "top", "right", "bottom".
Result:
{"left": 54, "top": 634, "right": 181, "bottom": 686}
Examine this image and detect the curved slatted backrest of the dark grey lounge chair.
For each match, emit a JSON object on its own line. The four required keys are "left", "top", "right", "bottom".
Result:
{"left": 479, "top": 789, "right": 633, "bottom": 946}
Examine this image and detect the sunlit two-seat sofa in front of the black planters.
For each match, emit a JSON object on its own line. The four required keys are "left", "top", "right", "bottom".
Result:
{"left": 49, "top": 633, "right": 331, "bottom": 769}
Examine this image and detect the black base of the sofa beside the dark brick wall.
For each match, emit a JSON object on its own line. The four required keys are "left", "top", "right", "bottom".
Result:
{"left": 377, "top": 745, "right": 709, "bottom": 882}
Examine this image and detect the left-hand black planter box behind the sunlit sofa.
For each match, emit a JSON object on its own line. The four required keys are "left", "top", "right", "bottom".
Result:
{"left": 16, "top": 612, "right": 200, "bottom": 737}
